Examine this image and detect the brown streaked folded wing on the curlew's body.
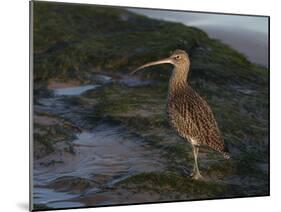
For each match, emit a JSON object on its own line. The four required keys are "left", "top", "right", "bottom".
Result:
{"left": 168, "top": 88, "right": 224, "bottom": 152}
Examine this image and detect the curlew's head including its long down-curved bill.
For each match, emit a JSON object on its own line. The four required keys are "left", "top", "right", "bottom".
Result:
{"left": 131, "top": 49, "right": 190, "bottom": 74}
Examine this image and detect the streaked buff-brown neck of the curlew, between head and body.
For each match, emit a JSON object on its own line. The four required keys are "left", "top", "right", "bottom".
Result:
{"left": 169, "top": 68, "right": 188, "bottom": 94}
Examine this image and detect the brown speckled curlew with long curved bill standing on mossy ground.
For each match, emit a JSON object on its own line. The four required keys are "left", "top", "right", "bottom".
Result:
{"left": 131, "top": 50, "right": 230, "bottom": 179}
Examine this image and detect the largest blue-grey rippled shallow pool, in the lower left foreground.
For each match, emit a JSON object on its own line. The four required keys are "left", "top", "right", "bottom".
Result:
{"left": 34, "top": 125, "right": 163, "bottom": 207}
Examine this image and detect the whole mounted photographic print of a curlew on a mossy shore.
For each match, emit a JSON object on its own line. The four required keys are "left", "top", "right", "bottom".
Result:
{"left": 30, "top": 1, "right": 269, "bottom": 210}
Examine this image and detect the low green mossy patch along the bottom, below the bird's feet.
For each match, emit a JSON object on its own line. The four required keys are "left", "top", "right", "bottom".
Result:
{"left": 117, "top": 172, "right": 245, "bottom": 199}
